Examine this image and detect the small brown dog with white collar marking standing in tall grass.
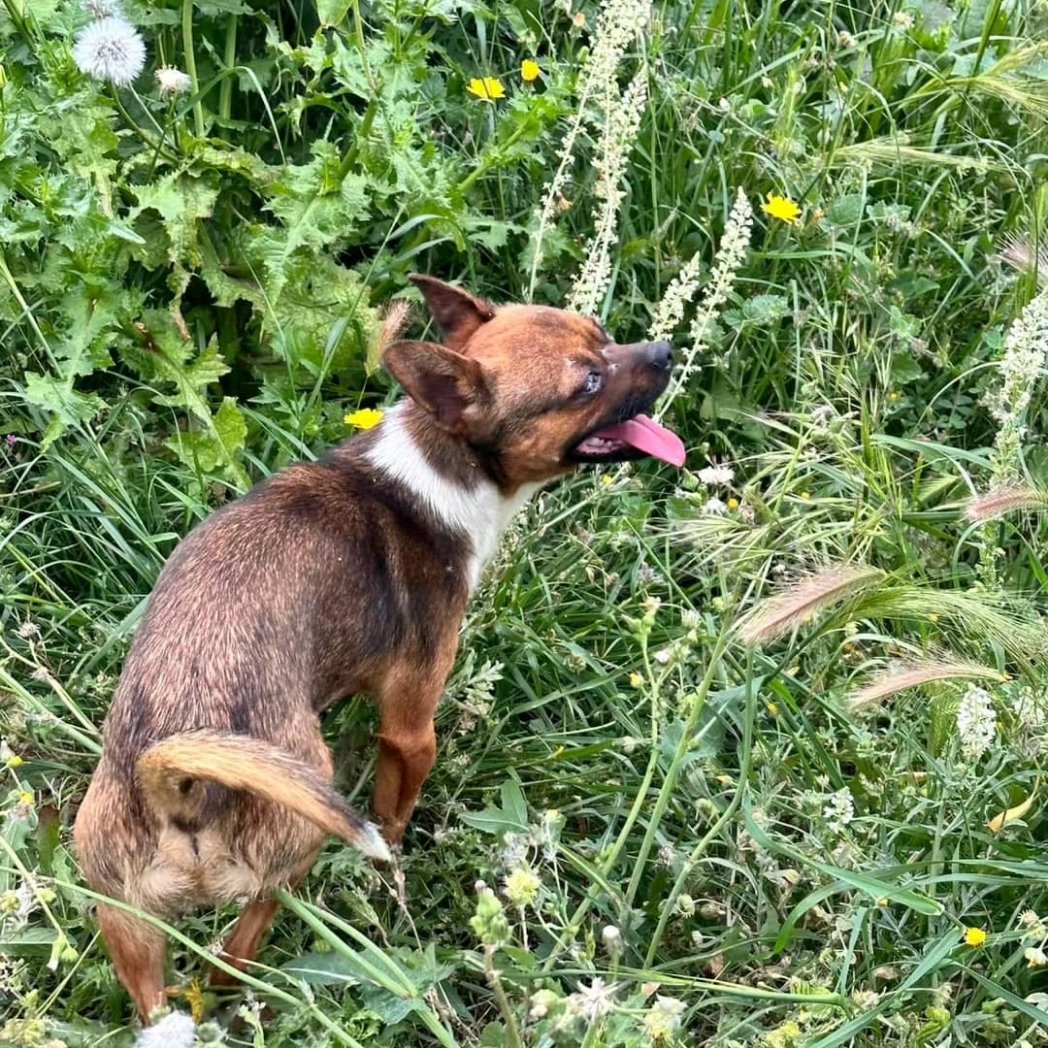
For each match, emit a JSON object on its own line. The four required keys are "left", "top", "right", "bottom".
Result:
{"left": 74, "top": 277, "right": 683, "bottom": 1022}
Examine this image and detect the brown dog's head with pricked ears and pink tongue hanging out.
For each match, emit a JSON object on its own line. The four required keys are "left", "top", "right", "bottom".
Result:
{"left": 384, "top": 276, "right": 684, "bottom": 486}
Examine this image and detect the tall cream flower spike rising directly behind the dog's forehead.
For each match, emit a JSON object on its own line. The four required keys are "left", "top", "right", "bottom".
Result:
{"left": 568, "top": 69, "right": 648, "bottom": 313}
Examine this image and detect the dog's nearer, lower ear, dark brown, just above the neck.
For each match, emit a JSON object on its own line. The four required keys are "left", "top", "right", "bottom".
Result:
{"left": 383, "top": 342, "right": 490, "bottom": 433}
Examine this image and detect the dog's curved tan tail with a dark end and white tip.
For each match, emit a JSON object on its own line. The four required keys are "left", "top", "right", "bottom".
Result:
{"left": 135, "top": 729, "right": 390, "bottom": 861}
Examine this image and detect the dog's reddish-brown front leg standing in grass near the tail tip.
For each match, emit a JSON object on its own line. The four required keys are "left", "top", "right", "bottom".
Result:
{"left": 373, "top": 651, "right": 454, "bottom": 845}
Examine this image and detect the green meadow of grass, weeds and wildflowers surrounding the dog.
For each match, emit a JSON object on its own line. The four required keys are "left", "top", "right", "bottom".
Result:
{"left": 0, "top": 0, "right": 1048, "bottom": 1048}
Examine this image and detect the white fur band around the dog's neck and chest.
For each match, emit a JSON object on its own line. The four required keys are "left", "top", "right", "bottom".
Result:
{"left": 367, "top": 407, "right": 542, "bottom": 593}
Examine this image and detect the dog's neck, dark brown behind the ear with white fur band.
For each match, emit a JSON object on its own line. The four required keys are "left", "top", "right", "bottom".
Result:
{"left": 367, "top": 400, "right": 542, "bottom": 592}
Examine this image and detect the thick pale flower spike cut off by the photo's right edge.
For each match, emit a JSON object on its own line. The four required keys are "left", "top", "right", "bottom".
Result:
{"left": 988, "top": 287, "right": 1048, "bottom": 482}
